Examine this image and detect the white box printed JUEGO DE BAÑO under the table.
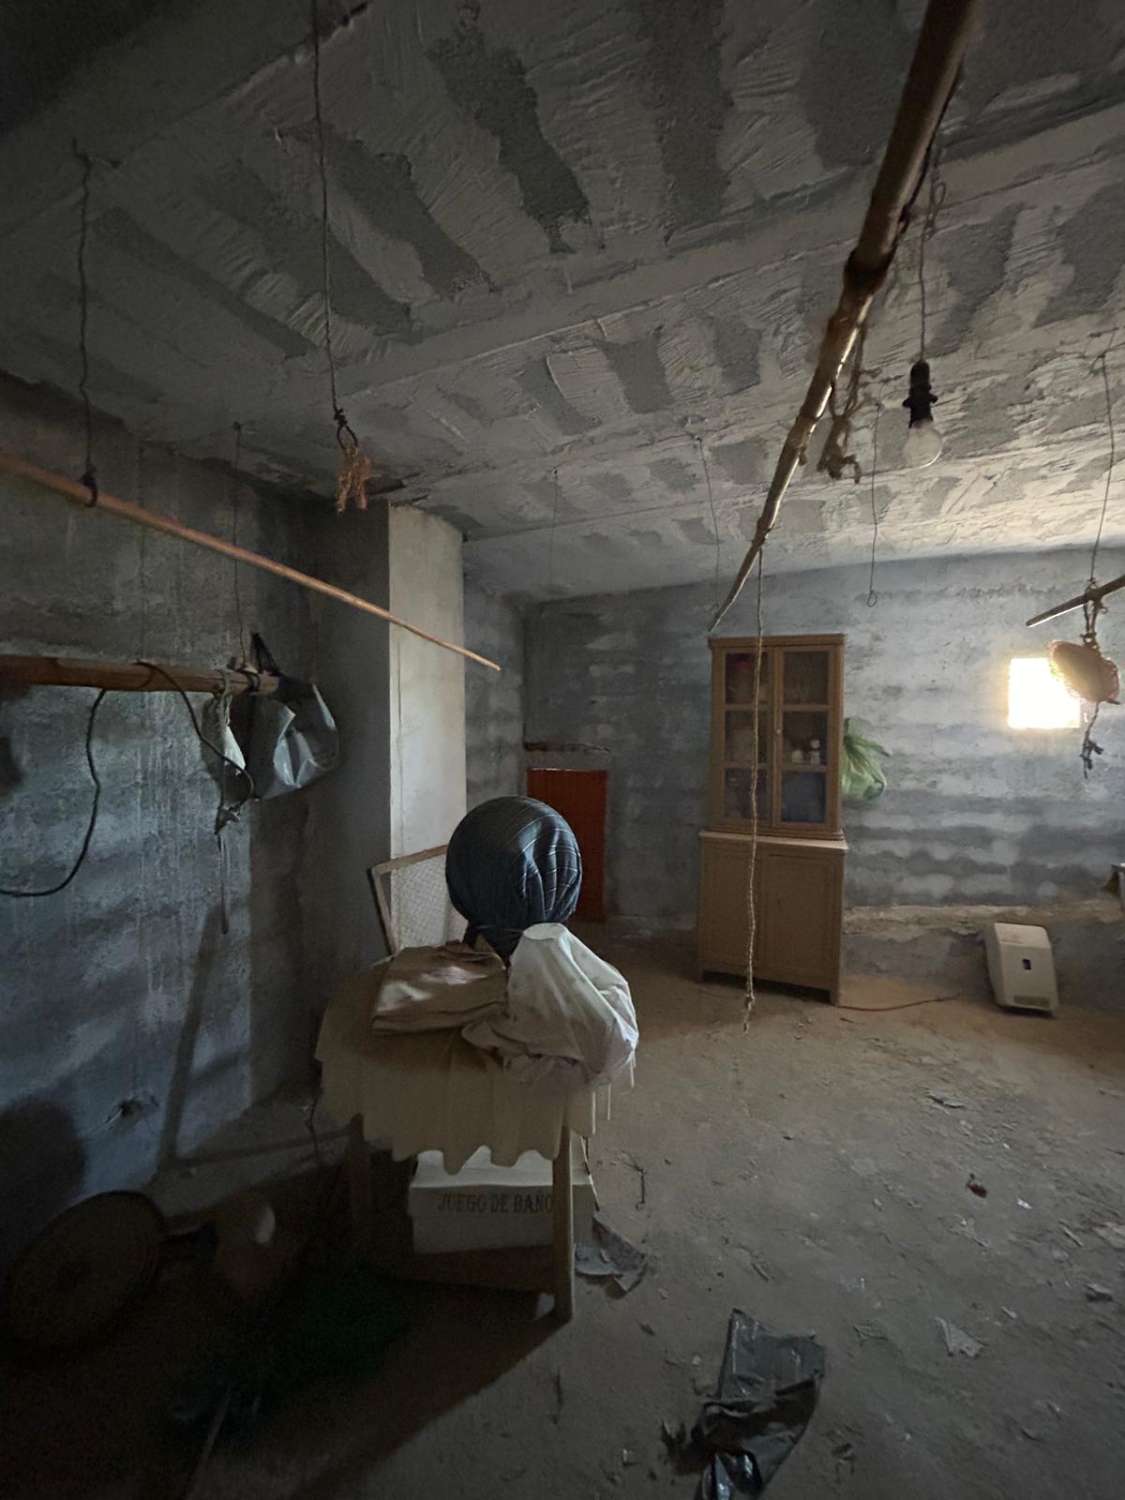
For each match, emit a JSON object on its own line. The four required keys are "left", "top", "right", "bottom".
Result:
{"left": 407, "top": 1142, "right": 594, "bottom": 1256}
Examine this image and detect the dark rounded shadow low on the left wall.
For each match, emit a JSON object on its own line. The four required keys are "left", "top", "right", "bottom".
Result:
{"left": 0, "top": 1094, "right": 86, "bottom": 1268}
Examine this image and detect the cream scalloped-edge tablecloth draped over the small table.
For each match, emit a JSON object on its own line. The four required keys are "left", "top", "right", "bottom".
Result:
{"left": 317, "top": 966, "right": 611, "bottom": 1172}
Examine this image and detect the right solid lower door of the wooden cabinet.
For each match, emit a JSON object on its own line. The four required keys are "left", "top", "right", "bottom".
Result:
{"left": 758, "top": 848, "right": 843, "bottom": 995}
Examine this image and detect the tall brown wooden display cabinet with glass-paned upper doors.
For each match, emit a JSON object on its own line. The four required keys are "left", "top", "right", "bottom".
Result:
{"left": 699, "top": 636, "right": 848, "bottom": 1001}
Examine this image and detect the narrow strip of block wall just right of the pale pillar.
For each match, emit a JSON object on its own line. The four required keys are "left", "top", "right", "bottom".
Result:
{"left": 465, "top": 579, "right": 527, "bottom": 807}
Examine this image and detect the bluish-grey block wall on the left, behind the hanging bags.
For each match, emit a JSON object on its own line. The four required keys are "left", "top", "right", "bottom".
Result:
{"left": 0, "top": 380, "right": 389, "bottom": 1265}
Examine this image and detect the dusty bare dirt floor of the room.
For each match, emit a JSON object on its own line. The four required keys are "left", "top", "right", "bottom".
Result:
{"left": 0, "top": 944, "right": 1125, "bottom": 1500}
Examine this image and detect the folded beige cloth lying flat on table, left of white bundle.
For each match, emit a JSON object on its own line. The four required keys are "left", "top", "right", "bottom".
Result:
{"left": 370, "top": 942, "right": 507, "bottom": 1034}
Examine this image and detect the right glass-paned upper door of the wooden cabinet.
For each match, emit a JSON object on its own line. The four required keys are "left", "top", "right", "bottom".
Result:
{"left": 777, "top": 648, "right": 831, "bottom": 828}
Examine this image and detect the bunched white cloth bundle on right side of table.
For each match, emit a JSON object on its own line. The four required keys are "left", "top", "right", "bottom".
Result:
{"left": 462, "top": 923, "right": 638, "bottom": 1085}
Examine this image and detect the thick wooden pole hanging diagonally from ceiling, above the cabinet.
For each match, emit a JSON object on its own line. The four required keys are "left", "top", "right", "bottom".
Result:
{"left": 711, "top": 0, "right": 981, "bottom": 630}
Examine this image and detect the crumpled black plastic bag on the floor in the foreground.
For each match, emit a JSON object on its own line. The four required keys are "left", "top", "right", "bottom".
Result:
{"left": 678, "top": 1308, "right": 825, "bottom": 1500}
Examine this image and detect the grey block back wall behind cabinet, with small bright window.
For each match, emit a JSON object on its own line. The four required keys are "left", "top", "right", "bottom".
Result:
{"left": 527, "top": 549, "right": 1125, "bottom": 927}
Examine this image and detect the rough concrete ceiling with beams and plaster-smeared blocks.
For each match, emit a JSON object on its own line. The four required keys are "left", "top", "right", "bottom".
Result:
{"left": 0, "top": 0, "right": 1125, "bottom": 597}
